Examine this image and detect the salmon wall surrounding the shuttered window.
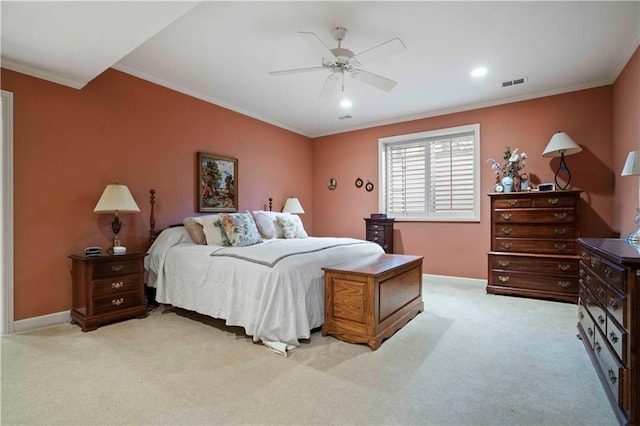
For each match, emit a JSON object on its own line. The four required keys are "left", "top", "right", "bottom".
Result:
{"left": 313, "top": 86, "right": 615, "bottom": 279}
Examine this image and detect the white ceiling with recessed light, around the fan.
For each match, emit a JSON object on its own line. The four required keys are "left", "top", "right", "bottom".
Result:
{"left": 0, "top": 0, "right": 640, "bottom": 137}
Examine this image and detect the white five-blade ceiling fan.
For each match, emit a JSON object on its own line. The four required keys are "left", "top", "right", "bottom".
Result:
{"left": 269, "top": 27, "right": 407, "bottom": 98}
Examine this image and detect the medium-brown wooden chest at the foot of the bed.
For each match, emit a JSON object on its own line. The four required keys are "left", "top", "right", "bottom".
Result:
{"left": 322, "top": 254, "right": 424, "bottom": 350}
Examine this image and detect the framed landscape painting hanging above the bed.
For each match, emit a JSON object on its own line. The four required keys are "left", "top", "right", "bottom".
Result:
{"left": 197, "top": 152, "right": 238, "bottom": 212}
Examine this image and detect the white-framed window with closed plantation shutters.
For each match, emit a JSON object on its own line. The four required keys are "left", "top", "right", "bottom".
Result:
{"left": 378, "top": 124, "right": 480, "bottom": 222}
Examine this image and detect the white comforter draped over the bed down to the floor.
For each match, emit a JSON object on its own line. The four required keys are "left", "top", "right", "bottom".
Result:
{"left": 145, "top": 227, "right": 384, "bottom": 346}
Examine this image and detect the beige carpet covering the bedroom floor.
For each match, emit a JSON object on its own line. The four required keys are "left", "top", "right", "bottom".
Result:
{"left": 0, "top": 276, "right": 617, "bottom": 425}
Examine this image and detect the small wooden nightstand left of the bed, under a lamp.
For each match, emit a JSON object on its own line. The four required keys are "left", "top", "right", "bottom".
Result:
{"left": 69, "top": 252, "right": 147, "bottom": 331}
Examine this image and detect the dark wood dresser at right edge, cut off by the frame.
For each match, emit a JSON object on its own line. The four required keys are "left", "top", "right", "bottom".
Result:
{"left": 578, "top": 238, "right": 640, "bottom": 425}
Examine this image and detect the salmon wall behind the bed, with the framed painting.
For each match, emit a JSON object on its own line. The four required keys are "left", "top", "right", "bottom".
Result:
{"left": 2, "top": 69, "right": 313, "bottom": 320}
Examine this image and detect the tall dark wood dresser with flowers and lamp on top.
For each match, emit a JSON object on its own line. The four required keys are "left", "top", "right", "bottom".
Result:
{"left": 487, "top": 191, "right": 580, "bottom": 303}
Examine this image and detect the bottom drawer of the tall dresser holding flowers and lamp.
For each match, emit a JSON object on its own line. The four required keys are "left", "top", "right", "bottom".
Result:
{"left": 491, "top": 270, "right": 578, "bottom": 294}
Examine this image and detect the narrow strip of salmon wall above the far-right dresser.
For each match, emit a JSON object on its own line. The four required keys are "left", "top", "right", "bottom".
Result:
{"left": 613, "top": 48, "right": 640, "bottom": 236}
